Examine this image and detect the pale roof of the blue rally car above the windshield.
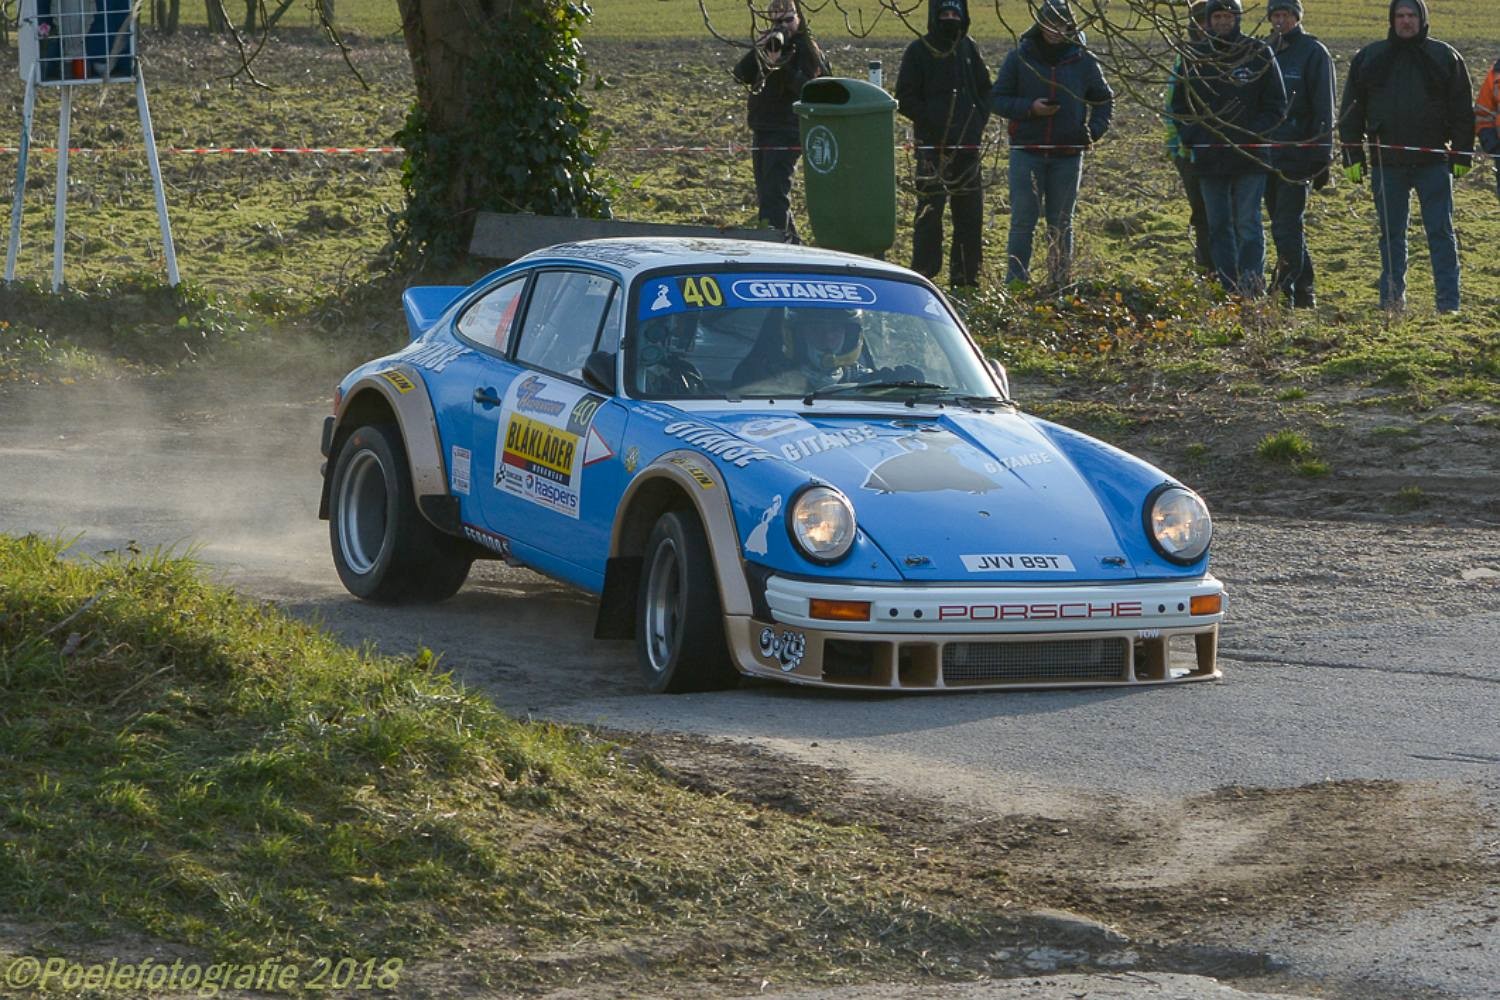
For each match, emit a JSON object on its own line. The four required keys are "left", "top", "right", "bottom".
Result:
{"left": 516, "top": 237, "right": 917, "bottom": 282}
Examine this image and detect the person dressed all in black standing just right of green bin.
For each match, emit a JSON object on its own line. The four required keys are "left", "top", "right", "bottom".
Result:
{"left": 896, "top": 0, "right": 990, "bottom": 286}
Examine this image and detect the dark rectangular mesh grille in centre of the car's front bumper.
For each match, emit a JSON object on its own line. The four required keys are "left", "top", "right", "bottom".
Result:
{"left": 942, "top": 639, "right": 1130, "bottom": 685}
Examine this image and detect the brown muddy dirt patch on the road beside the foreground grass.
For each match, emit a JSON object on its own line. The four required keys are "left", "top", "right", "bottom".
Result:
{"left": 612, "top": 733, "right": 1500, "bottom": 1000}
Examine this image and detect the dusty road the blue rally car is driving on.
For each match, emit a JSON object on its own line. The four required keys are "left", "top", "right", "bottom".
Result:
{"left": 0, "top": 373, "right": 1500, "bottom": 999}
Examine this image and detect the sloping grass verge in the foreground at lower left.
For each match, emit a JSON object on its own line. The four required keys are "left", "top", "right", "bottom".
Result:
{"left": 0, "top": 537, "right": 1004, "bottom": 988}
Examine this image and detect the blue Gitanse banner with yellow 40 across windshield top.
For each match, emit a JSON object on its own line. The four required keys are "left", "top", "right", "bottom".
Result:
{"left": 636, "top": 273, "right": 948, "bottom": 319}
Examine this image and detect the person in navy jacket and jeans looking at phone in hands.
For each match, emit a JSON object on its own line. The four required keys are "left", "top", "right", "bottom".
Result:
{"left": 990, "top": 0, "right": 1115, "bottom": 285}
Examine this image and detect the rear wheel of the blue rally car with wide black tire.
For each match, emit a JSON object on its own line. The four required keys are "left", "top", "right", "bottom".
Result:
{"left": 329, "top": 424, "right": 474, "bottom": 604}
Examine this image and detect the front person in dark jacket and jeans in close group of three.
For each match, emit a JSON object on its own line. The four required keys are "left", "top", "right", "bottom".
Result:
{"left": 1172, "top": 0, "right": 1287, "bottom": 295}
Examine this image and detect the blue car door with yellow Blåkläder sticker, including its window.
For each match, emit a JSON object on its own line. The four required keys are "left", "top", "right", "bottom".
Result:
{"left": 476, "top": 268, "right": 626, "bottom": 591}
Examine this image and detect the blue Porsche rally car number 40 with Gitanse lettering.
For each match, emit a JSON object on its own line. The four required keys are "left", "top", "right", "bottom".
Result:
{"left": 321, "top": 238, "right": 1224, "bottom": 691}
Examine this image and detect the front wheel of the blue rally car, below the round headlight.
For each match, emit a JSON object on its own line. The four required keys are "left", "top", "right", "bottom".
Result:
{"left": 636, "top": 511, "right": 740, "bottom": 694}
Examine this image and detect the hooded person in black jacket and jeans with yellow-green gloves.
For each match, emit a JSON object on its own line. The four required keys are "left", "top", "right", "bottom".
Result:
{"left": 1338, "top": 0, "right": 1475, "bottom": 313}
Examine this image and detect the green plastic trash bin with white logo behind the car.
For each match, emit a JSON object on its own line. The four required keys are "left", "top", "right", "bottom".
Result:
{"left": 792, "top": 76, "right": 896, "bottom": 256}
